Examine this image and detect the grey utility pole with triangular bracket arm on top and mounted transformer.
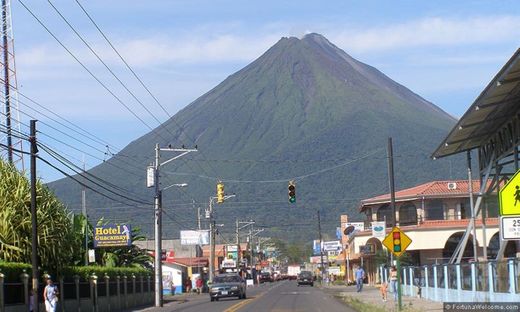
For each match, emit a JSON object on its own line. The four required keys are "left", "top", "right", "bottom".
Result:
{"left": 147, "top": 144, "right": 197, "bottom": 307}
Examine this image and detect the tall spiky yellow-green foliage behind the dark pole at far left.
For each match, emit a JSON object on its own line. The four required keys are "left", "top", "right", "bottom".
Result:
{"left": 0, "top": 160, "right": 78, "bottom": 269}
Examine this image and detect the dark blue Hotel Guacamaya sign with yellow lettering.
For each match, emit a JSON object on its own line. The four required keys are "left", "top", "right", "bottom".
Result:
{"left": 94, "top": 224, "right": 132, "bottom": 248}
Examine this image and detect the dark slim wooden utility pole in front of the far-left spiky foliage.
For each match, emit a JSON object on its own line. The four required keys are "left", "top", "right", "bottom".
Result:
{"left": 30, "top": 120, "right": 39, "bottom": 312}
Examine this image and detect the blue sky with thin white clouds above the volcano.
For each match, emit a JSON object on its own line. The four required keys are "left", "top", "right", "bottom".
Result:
{"left": 4, "top": 0, "right": 520, "bottom": 181}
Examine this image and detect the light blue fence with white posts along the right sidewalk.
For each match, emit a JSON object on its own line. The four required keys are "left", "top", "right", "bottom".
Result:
{"left": 379, "top": 259, "right": 520, "bottom": 302}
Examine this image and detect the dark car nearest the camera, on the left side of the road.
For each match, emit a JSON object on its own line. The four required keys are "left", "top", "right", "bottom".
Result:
{"left": 209, "top": 273, "right": 246, "bottom": 301}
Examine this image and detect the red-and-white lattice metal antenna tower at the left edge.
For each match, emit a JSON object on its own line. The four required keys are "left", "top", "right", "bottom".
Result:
{"left": 0, "top": 0, "right": 24, "bottom": 170}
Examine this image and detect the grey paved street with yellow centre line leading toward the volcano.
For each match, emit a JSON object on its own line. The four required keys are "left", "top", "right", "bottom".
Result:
{"left": 143, "top": 281, "right": 354, "bottom": 312}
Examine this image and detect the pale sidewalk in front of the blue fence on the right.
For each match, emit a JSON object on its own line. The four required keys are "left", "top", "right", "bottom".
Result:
{"left": 323, "top": 285, "right": 443, "bottom": 311}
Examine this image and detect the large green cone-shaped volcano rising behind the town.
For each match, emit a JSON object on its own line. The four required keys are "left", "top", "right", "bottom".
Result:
{"left": 50, "top": 34, "right": 462, "bottom": 239}
